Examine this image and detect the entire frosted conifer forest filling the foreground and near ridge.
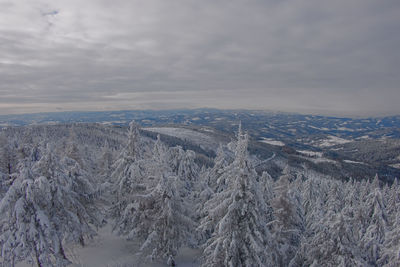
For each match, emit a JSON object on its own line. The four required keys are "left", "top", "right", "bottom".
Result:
{"left": 0, "top": 123, "right": 400, "bottom": 267}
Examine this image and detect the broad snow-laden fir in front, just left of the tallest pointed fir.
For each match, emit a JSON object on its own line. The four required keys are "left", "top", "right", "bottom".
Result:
{"left": 124, "top": 174, "right": 195, "bottom": 260}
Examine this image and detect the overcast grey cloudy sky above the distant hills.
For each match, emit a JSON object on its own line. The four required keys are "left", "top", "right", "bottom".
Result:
{"left": 0, "top": 0, "right": 400, "bottom": 116}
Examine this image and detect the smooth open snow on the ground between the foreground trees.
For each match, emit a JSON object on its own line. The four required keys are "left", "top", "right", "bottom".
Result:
{"left": 16, "top": 225, "right": 201, "bottom": 267}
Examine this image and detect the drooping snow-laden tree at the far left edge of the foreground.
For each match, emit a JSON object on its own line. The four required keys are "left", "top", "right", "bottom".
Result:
{"left": 0, "top": 156, "right": 69, "bottom": 267}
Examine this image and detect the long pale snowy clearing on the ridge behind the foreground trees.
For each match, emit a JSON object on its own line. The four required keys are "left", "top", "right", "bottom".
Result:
{"left": 143, "top": 127, "right": 218, "bottom": 150}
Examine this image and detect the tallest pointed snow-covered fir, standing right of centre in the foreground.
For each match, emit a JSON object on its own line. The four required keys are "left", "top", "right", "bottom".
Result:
{"left": 200, "top": 131, "right": 276, "bottom": 266}
